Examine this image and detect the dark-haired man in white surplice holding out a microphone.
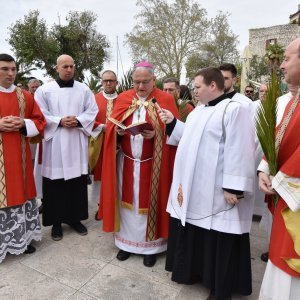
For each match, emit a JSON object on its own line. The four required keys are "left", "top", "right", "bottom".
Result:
{"left": 160, "top": 68, "right": 255, "bottom": 299}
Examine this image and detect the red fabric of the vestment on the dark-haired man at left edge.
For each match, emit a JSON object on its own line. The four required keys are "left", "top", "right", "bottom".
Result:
{"left": 0, "top": 91, "right": 46, "bottom": 207}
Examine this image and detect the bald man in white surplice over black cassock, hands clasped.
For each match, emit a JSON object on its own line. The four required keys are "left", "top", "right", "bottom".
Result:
{"left": 35, "top": 55, "right": 98, "bottom": 241}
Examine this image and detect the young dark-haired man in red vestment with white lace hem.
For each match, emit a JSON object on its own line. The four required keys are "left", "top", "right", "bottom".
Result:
{"left": 0, "top": 54, "right": 46, "bottom": 262}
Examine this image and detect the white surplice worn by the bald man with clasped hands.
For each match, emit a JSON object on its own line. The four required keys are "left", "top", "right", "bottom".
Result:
{"left": 34, "top": 81, "right": 98, "bottom": 180}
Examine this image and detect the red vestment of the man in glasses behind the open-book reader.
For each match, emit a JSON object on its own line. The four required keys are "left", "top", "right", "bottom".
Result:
{"left": 93, "top": 93, "right": 116, "bottom": 181}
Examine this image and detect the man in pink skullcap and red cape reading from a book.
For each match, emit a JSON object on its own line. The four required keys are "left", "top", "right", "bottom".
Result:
{"left": 100, "top": 61, "right": 178, "bottom": 267}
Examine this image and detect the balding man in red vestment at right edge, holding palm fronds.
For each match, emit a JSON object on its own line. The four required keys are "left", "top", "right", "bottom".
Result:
{"left": 258, "top": 38, "right": 300, "bottom": 300}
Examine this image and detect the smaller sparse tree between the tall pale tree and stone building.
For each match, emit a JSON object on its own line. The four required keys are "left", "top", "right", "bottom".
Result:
{"left": 186, "top": 11, "right": 239, "bottom": 78}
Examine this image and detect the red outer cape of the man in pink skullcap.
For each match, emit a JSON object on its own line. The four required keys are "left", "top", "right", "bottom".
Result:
{"left": 99, "top": 88, "right": 179, "bottom": 238}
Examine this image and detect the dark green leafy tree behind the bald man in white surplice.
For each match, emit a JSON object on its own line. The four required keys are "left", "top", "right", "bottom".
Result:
{"left": 8, "top": 10, "right": 109, "bottom": 80}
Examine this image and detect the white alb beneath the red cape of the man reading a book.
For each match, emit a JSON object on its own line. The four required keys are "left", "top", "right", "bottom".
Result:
{"left": 115, "top": 98, "right": 167, "bottom": 255}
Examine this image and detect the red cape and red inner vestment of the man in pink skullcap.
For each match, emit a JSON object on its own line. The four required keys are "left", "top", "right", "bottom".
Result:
{"left": 100, "top": 88, "right": 179, "bottom": 239}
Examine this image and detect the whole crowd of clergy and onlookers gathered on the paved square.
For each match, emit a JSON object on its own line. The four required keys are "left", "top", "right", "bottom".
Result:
{"left": 0, "top": 38, "right": 300, "bottom": 300}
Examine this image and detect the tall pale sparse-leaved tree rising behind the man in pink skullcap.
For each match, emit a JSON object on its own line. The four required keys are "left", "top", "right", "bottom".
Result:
{"left": 126, "top": 0, "right": 208, "bottom": 78}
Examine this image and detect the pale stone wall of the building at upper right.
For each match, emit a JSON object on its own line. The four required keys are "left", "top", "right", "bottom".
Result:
{"left": 249, "top": 24, "right": 300, "bottom": 57}
